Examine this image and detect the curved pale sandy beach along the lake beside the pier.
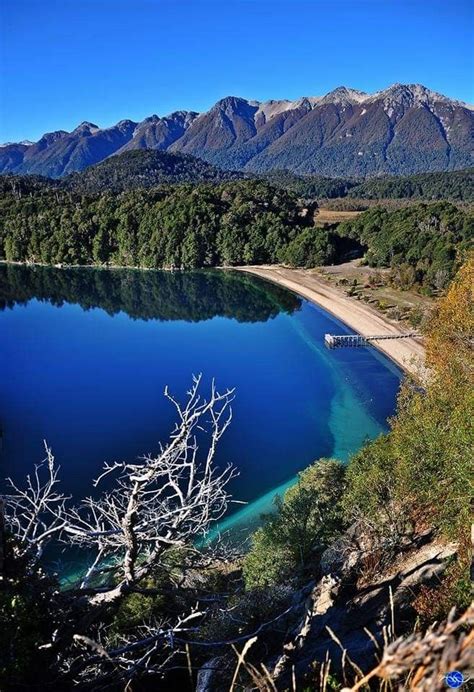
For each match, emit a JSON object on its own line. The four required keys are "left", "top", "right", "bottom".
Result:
{"left": 236, "top": 266, "right": 425, "bottom": 377}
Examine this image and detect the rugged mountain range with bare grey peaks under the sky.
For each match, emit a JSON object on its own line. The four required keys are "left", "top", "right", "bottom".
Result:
{"left": 0, "top": 84, "right": 474, "bottom": 178}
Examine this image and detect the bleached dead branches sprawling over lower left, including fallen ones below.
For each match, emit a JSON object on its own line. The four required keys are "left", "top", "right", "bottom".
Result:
{"left": 5, "top": 376, "right": 241, "bottom": 681}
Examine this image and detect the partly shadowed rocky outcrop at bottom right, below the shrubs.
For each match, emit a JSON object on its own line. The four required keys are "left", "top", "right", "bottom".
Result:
{"left": 273, "top": 528, "right": 457, "bottom": 689}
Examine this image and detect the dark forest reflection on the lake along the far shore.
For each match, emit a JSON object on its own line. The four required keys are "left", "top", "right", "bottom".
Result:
{"left": 0, "top": 264, "right": 301, "bottom": 322}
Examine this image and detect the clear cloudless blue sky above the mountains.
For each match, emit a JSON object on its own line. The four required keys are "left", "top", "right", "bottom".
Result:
{"left": 0, "top": 0, "right": 474, "bottom": 142}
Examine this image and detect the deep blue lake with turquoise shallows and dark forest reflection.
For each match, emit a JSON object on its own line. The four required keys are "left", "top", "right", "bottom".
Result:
{"left": 0, "top": 265, "right": 401, "bottom": 536}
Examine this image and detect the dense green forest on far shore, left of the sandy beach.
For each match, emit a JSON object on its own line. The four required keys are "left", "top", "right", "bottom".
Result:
{"left": 0, "top": 180, "right": 340, "bottom": 269}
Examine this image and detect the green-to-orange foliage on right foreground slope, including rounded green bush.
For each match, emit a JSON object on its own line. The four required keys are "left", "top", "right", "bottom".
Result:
{"left": 244, "top": 260, "right": 474, "bottom": 619}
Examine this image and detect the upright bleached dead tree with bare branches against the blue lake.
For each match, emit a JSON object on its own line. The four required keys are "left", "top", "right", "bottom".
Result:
{"left": 62, "top": 377, "right": 239, "bottom": 604}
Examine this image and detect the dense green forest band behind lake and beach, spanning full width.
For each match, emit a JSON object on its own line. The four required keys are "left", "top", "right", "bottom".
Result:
{"left": 0, "top": 173, "right": 474, "bottom": 290}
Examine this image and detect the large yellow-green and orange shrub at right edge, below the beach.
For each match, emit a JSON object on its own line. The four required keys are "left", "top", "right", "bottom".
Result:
{"left": 343, "top": 261, "right": 474, "bottom": 556}
